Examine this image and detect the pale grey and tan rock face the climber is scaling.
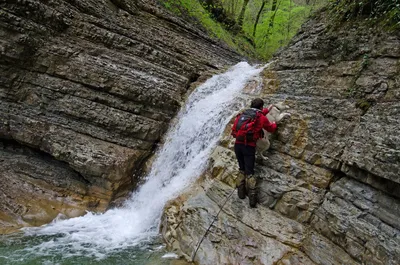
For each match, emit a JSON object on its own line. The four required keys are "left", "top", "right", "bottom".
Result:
{"left": 162, "top": 13, "right": 400, "bottom": 265}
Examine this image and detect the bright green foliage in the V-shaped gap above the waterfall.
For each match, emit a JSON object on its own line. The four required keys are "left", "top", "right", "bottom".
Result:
{"left": 159, "top": 0, "right": 328, "bottom": 60}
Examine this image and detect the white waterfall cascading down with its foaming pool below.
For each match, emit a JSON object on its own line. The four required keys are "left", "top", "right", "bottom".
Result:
{"left": 0, "top": 62, "right": 268, "bottom": 264}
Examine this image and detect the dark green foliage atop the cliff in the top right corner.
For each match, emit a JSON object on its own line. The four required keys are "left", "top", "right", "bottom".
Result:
{"left": 328, "top": 0, "right": 400, "bottom": 29}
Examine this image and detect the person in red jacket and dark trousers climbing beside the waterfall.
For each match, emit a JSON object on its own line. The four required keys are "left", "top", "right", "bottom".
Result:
{"left": 232, "top": 98, "right": 277, "bottom": 208}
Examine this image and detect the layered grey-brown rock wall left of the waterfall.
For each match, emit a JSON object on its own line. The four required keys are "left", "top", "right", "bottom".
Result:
{"left": 0, "top": 0, "right": 240, "bottom": 231}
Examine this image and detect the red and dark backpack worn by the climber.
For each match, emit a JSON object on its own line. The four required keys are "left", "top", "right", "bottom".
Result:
{"left": 231, "top": 109, "right": 262, "bottom": 144}
